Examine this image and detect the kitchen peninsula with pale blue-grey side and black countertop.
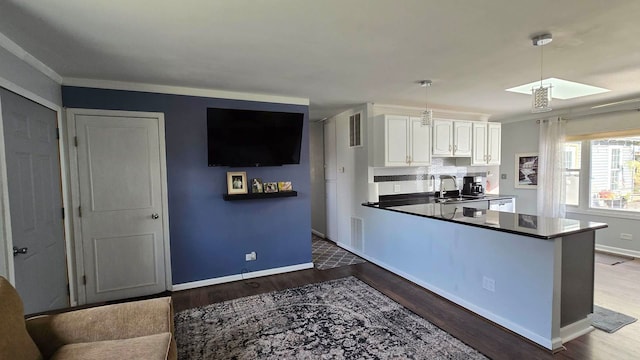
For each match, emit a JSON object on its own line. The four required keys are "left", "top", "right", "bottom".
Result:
{"left": 359, "top": 199, "right": 607, "bottom": 351}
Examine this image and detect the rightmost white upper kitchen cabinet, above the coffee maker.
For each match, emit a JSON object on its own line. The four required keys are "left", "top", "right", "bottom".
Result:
{"left": 471, "top": 122, "right": 502, "bottom": 165}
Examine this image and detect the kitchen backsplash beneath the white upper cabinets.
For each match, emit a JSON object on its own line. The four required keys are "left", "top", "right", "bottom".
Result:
{"left": 373, "top": 158, "right": 500, "bottom": 195}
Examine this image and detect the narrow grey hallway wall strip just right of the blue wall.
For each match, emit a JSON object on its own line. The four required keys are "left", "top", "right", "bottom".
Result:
{"left": 309, "top": 122, "right": 327, "bottom": 234}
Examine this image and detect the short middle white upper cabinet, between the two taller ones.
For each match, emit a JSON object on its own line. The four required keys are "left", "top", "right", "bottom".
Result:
{"left": 433, "top": 119, "right": 472, "bottom": 157}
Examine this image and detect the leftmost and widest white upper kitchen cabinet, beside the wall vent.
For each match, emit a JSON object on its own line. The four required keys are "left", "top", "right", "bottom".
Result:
{"left": 374, "top": 115, "right": 431, "bottom": 166}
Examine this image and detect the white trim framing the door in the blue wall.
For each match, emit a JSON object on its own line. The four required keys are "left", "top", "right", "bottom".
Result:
{"left": 66, "top": 108, "right": 172, "bottom": 304}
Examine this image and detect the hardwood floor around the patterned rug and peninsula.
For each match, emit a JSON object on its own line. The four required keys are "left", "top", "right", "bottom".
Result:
{"left": 172, "top": 259, "right": 640, "bottom": 360}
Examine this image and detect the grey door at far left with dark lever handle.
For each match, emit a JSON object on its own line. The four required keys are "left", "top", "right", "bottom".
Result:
{"left": 0, "top": 88, "right": 69, "bottom": 314}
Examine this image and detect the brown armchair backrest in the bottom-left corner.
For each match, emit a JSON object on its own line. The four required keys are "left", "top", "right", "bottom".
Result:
{"left": 0, "top": 276, "right": 42, "bottom": 360}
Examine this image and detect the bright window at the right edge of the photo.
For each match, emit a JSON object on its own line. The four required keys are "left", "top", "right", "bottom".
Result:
{"left": 588, "top": 136, "right": 640, "bottom": 212}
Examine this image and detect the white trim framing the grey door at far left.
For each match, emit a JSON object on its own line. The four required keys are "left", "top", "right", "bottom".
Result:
{"left": 0, "top": 77, "right": 78, "bottom": 306}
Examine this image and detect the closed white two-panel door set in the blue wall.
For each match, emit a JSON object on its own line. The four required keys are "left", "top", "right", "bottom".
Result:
{"left": 72, "top": 111, "right": 168, "bottom": 303}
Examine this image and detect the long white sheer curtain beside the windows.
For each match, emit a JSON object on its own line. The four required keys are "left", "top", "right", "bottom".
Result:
{"left": 538, "top": 118, "right": 566, "bottom": 217}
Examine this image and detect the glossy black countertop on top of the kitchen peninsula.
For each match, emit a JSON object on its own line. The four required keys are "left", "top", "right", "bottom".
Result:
{"left": 362, "top": 195, "right": 608, "bottom": 239}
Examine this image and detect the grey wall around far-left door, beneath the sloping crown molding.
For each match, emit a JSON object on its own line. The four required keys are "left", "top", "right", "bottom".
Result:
{"left": 0, "top": 39, "right": 62, "bottom": 277}
